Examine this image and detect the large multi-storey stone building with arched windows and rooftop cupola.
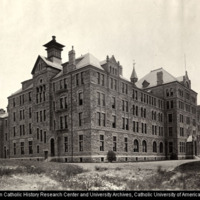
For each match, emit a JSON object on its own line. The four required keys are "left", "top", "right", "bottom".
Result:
{"left": 0, "top": 36, "right": 199, "bottom": 162}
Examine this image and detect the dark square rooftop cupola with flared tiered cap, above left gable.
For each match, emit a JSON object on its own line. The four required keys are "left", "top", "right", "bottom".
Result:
{"left": 43, "top": 36, "right": 65, "bottom": 64}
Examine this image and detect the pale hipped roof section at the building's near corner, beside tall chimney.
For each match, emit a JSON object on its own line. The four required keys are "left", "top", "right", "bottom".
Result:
{"left": 76, "top": 53, "right": 103, "bottom": 69}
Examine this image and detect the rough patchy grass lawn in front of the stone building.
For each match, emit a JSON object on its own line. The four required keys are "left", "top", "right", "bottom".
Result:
{"left": 0, "top": 160, "right": 200, "bottom": 190}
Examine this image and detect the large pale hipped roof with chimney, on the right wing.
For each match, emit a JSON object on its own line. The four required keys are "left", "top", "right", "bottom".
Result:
{"left": 136, "top": 68, "right": 179, "bottom": 88}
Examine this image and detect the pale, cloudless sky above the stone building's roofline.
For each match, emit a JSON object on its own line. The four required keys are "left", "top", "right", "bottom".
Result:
{"left": 0, "top": 0, "right": 200, "bottom": 109}
